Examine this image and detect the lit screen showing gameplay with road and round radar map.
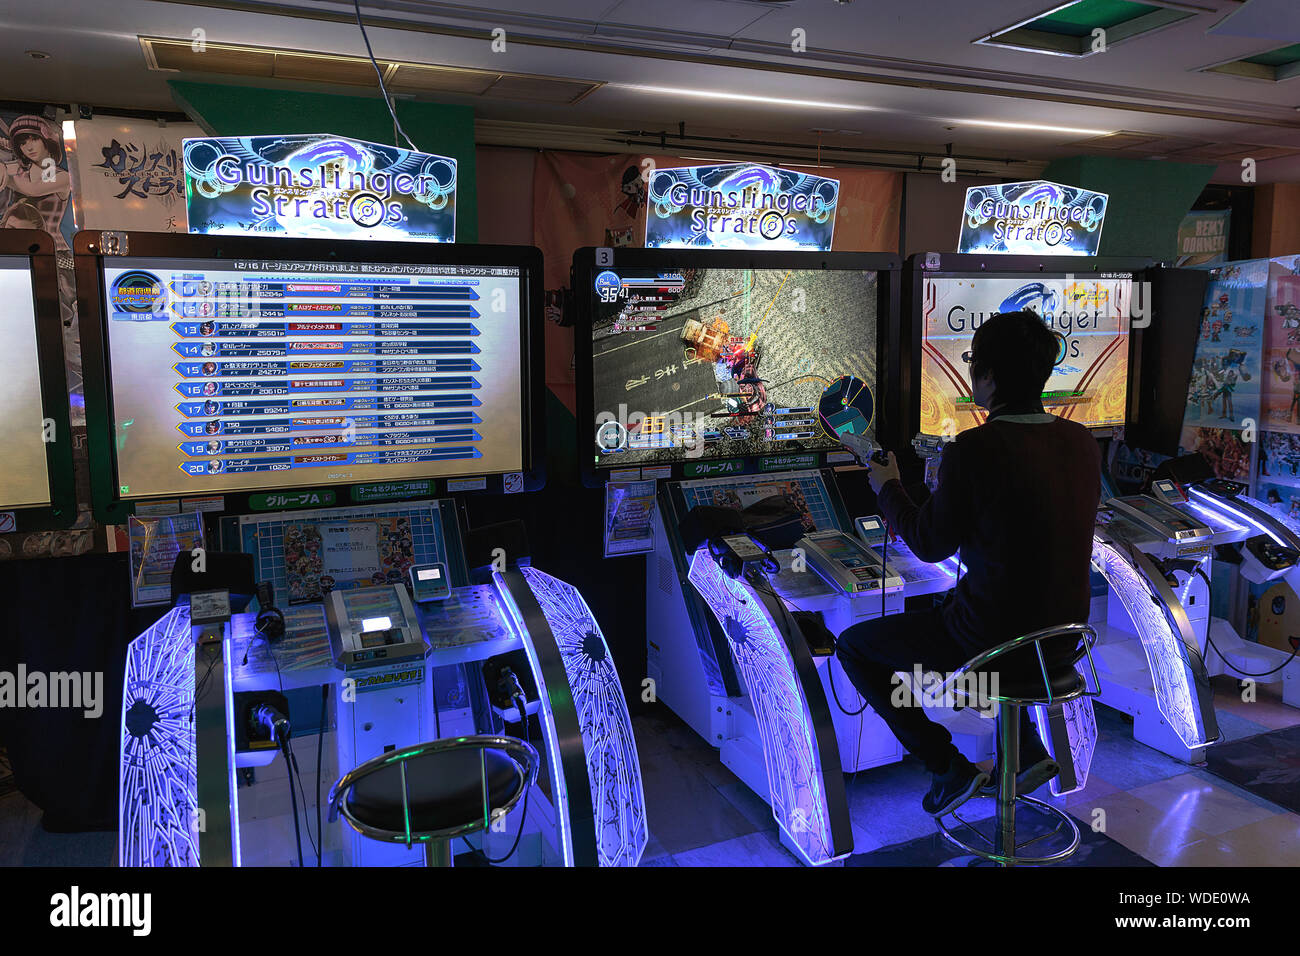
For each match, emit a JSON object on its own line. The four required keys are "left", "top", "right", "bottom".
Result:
{"left": 590, "top": 268, "right": 878, "bottom": 468}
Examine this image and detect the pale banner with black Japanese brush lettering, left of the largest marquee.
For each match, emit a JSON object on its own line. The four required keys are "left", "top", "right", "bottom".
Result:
{"left": 69, "top": 116, "right": 203, "bottom": 233}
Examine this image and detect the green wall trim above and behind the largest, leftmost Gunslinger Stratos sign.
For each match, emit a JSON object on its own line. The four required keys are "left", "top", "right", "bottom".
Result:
{"left": 168, "top": 79, "right": 478, "bottom": 242}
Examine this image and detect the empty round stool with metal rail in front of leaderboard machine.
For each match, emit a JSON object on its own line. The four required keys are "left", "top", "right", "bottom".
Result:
{"left": 329, "top": 734, "right": 540, "bottom": 866}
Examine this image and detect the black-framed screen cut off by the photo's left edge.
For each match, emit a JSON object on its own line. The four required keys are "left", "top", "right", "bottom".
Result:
{"left": 0, "top": 229, "right": 77, "bottom": 533}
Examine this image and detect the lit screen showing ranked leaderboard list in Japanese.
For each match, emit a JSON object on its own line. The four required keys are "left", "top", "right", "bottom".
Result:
{"left": 104, "top": 258, "right": 524, "bottom": 498}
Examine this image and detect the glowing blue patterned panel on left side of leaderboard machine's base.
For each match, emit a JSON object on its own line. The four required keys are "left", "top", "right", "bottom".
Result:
{"left": 117, "top": 605, "right": 199, "bottom": 866}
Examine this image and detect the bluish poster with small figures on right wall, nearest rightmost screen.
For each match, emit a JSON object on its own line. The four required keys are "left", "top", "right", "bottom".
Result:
{"left": 1183, "top": 259, "right": 1269, "bottom": 429}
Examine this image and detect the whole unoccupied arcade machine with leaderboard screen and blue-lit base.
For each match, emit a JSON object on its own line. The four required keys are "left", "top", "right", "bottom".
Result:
{"left": 75, "top": 233, "right": 647, "bottom": 866}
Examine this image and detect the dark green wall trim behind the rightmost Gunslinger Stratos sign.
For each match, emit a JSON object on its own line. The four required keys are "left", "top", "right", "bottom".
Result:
{"left": 1041, "top": 156, "right": 1217, "bottom": 259}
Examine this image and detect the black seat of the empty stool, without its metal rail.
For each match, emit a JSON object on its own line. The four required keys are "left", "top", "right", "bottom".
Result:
{"left": 345, "top": 748, "right": 524, "bottom": 832}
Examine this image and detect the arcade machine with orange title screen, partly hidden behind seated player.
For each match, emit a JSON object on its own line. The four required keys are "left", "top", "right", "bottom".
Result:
{"left": 905, "top": 252, "right": 1240, "bottom": 770}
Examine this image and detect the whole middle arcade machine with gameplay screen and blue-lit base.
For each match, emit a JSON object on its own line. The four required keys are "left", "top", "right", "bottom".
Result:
{"left": 572, "top": 248, "right": 992, "bottom": 865}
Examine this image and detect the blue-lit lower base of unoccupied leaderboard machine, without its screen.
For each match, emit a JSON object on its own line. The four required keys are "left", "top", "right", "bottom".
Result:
{"left": 118, "top": 567, "right": 647, "bottom": 866}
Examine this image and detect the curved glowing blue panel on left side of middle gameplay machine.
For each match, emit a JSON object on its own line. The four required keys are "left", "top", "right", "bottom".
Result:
{"left": 689, "top": 549, "right": 840, "bottom": 865}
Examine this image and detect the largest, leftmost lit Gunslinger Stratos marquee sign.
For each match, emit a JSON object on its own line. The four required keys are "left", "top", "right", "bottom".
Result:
{"left": 183, "top": 133, "right": 456, "bottom": 242}
